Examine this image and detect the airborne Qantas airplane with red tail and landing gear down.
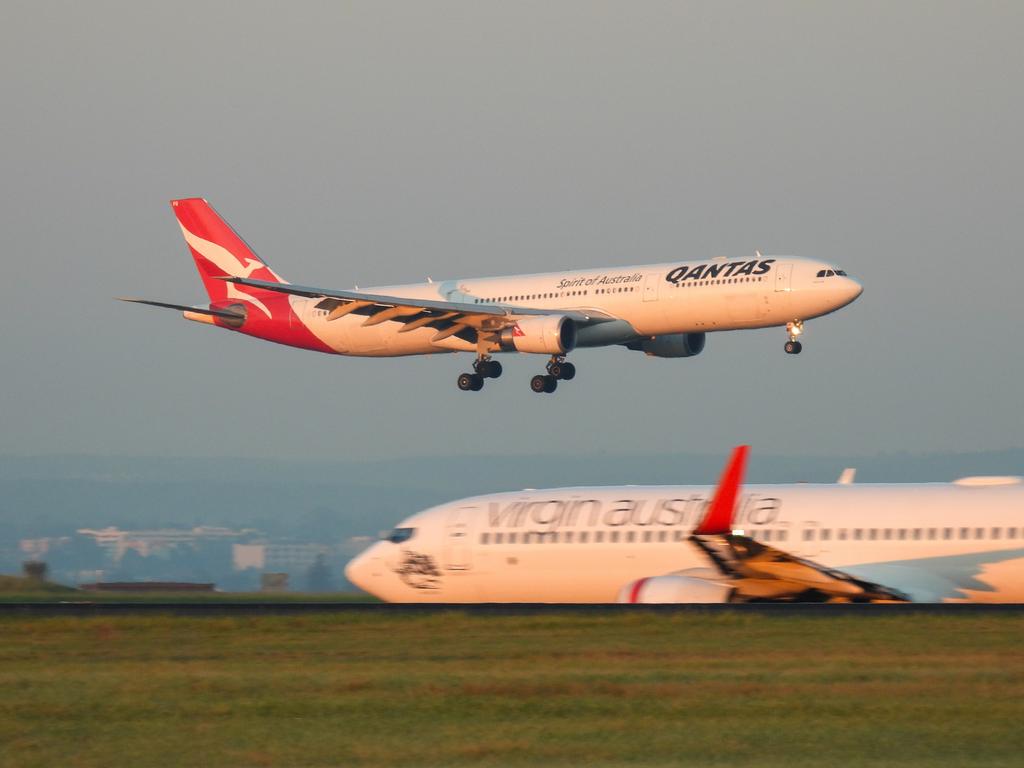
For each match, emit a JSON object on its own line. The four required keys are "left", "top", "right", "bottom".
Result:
{"left": 123, "top": 198, "right": 862, "bottom": 392}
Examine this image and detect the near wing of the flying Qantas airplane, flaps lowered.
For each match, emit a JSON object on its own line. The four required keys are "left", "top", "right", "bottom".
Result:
{"left": 222, "top": 276, "right": 615, "bottom": 341}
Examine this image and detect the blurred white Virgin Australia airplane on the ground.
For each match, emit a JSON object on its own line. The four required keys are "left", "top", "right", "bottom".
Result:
{"left": 345, "top": 446, "right": 1024, "bottom": 603}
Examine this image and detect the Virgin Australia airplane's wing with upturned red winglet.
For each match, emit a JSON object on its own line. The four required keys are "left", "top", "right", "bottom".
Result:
{"left": 690, "top": 445, "right": 909, "bottom": 602}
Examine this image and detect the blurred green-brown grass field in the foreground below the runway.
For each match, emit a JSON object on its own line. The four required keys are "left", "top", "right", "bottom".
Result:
{"left": 0, "top": 611, "right": 1024, "bottom": 767}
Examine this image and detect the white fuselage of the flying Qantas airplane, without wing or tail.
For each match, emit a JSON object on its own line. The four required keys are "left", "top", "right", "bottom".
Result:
{"left": 290, "top": 256, "right": 862, "bottom": 356}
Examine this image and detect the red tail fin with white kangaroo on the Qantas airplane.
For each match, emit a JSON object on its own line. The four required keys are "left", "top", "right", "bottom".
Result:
{"left": 171, "top": 198, "right": 285, "bottom": 302}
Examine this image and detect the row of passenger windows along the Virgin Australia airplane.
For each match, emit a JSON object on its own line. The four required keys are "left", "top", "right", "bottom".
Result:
{"left": 480, "top": 527, "right": 1024, "bottom": 544}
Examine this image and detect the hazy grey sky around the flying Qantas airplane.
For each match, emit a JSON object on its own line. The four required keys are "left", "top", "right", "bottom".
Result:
{"left": 0, "top": 0, "right": 1024, "bottom": 459}
